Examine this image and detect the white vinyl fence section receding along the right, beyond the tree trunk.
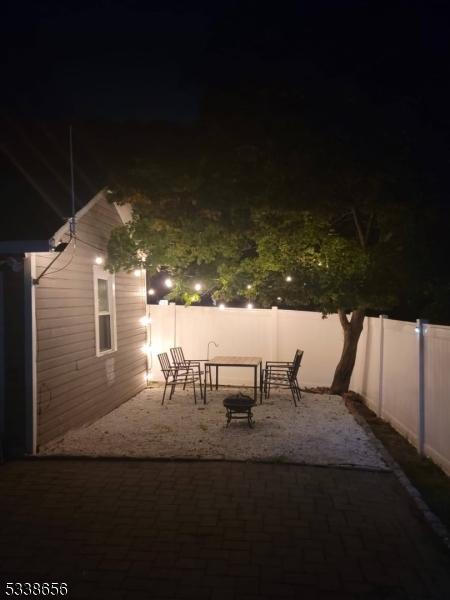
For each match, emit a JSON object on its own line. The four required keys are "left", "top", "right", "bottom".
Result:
{"left": 352, "top": 318, "right": 450, "bottom": 474}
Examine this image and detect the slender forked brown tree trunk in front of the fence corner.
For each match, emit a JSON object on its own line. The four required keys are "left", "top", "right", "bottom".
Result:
{"left": 331, "top": 308, "right": 365, "bottom": 394}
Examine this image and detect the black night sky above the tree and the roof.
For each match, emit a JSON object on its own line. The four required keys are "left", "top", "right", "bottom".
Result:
{"left": 0, "top": 0, "right": 450, "bottom": 225}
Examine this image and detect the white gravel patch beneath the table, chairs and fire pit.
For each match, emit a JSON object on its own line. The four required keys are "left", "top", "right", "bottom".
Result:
{"left": 40, "top": 386, "right": 386, "bottom": 469}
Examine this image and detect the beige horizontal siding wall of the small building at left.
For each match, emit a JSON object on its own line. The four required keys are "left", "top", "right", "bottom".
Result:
{"left": 36, "top": 198, "right": 146, "bottom": 446}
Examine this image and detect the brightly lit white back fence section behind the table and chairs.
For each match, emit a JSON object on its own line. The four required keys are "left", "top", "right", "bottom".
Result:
{"left": 151, "top": 305, "right": 342, "bottom": 386}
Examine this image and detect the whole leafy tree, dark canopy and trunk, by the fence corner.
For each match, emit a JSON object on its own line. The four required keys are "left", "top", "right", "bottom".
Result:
{"left": 109, "top": 84, "right": 422, "bottom": 393}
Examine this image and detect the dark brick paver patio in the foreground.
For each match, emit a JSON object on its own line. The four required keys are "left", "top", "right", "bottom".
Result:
{"left": 0, "top": 459, "right": 450, "bottom": 600}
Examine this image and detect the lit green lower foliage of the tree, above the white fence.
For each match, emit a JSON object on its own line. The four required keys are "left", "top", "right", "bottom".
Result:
{"left": 109, "top": 186, "right": 412, "bottom": 313}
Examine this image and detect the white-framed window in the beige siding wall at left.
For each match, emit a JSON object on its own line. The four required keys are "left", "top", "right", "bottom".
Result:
{"left": 94, "top": 266, "right": 117, "bottom": 356}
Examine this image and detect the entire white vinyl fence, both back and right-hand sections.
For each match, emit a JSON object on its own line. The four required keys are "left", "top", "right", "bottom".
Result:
{"left": 150, "top": 304, "right": 450, "bottom": 474}
